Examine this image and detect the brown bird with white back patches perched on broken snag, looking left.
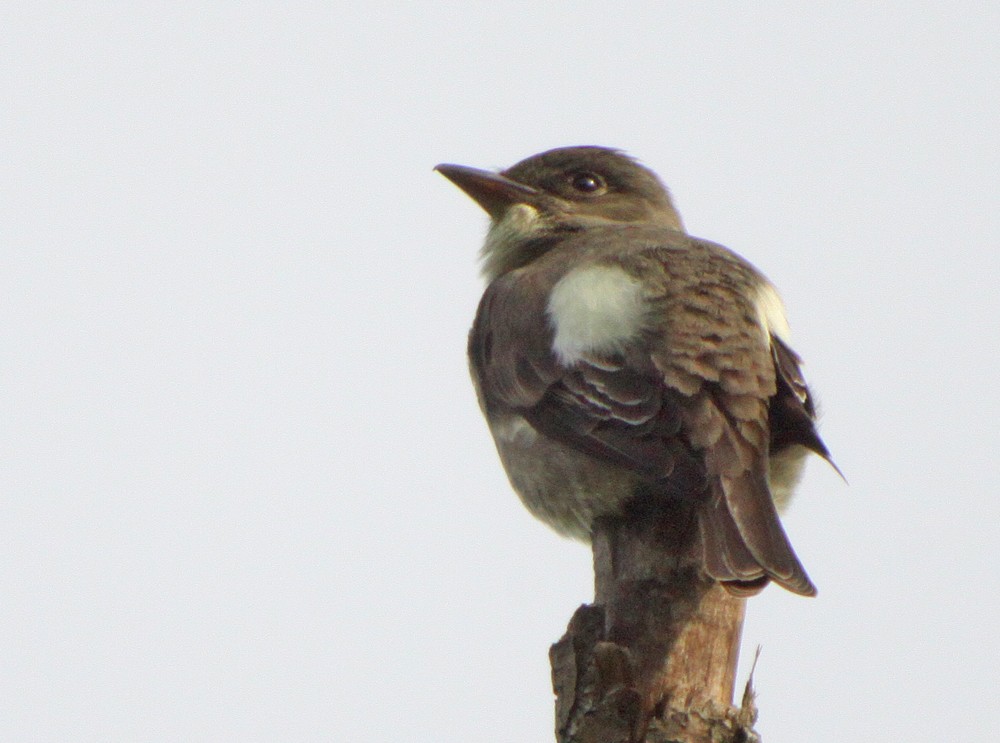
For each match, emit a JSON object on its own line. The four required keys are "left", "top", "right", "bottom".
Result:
{"left": 435, "top": 146, "right": 839, "bottom": 597}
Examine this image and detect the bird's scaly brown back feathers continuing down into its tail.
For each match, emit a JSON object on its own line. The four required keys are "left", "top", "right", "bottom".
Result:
{"left": 645, "top": 246, "right": 815, "bottom": 595}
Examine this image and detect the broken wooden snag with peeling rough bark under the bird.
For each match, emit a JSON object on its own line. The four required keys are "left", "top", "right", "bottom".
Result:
{"left": 549, "top": 514, "right": 758, "bottom": 743}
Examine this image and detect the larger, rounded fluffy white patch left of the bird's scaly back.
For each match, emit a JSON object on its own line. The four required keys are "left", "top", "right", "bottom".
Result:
{"left": 547, "top": 266, "right": 646, "bottom": 366}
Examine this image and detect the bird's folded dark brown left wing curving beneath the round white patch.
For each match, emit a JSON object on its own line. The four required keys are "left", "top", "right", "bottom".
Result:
{"left": 469, "top": 258, "right": 693, "bottom": 485}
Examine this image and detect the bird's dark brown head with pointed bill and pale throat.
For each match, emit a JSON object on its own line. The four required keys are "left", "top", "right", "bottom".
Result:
{"left": 436, "top": 147, "right": 683, "bottom": 279}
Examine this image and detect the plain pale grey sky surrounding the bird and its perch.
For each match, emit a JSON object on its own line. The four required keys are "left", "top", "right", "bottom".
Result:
{"left": 0, "top": 1, "right": 1000, "bottom": 743}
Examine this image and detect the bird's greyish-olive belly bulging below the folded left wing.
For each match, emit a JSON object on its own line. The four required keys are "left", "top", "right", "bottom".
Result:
{"left": 491, "top": 415, "right": 639, "bottom": 541}
